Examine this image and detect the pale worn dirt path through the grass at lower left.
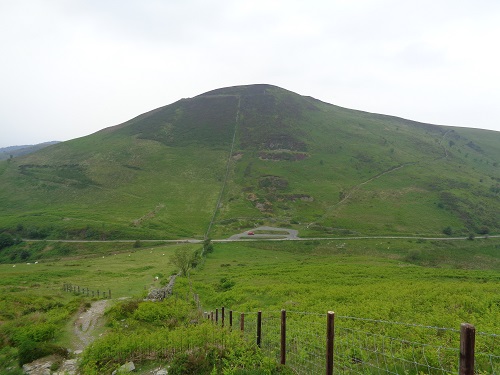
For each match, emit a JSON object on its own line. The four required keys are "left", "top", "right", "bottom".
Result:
{"left": 71, "top": 300, "right": 109, "bottom": 352}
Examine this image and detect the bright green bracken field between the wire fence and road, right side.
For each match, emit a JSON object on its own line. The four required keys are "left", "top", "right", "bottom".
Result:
{"left": 191, "top": 239, "right": 500, "bottom": 332}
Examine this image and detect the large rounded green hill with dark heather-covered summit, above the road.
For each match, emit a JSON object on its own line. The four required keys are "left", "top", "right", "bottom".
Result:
{"left": 0, "top": 85, "right": 500, "bottom": 239}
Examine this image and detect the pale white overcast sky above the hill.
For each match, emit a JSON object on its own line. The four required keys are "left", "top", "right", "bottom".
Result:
{"left": 0, "top": 0, "right": 500, "bottom": 147}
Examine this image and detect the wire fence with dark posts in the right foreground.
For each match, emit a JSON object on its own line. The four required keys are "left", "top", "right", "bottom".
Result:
{"left": 206, "top": 309, "right": 500, "bottom": 375}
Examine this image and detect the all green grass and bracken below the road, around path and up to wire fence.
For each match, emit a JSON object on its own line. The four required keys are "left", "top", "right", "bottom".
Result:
{"left": 0, "top": 238, "right": 500, "bottom": 374}
